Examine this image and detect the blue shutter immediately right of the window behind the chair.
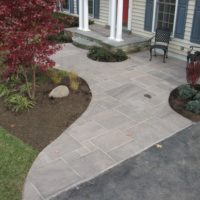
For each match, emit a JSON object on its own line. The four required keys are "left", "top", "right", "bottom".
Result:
{"left": 174, "top": 0, "right": 188, "bottom": 39}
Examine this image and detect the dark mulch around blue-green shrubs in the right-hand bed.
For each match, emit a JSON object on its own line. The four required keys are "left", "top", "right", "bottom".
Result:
{"left": 169, "top": 85, "right": 200, "bottom": 121}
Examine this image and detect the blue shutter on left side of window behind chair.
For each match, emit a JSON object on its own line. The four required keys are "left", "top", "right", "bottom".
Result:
{"left": 144, "top": 0, "right": 154, "bottom": 31}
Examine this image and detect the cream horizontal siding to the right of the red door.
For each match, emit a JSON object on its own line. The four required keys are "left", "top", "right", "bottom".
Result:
{"left": 132, "top": 0, "right": 200, "bottom": 56}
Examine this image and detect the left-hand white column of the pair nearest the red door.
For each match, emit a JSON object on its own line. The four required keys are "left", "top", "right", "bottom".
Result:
{"left": 110, "top": 0, "right": 117, "bottom": 40}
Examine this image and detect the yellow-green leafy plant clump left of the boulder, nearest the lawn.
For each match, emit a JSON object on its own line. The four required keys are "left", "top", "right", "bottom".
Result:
{"left": 5, "top": 94, "right": 35, "bottom": 112}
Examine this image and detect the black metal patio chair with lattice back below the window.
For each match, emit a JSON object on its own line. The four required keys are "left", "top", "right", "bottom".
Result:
{"left": 149, "top": 29, "right": 171, "bottom": 63}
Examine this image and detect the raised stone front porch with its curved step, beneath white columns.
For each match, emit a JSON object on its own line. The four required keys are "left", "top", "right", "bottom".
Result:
{"left": 65, "top": 25, "right": 149, "bottom": 52}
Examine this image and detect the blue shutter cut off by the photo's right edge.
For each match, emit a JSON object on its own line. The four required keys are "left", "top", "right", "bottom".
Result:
{"left": 191, "top": 0, "right": 200, "bottom": 44}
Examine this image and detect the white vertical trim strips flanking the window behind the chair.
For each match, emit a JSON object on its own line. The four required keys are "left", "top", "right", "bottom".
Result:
{"left": 151, "top": 0, "right": 179, "bottom": 38}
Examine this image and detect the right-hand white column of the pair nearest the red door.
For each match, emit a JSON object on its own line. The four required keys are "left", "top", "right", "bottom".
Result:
{"left": 116, "top": 0, "right": 123, "bottom": 42}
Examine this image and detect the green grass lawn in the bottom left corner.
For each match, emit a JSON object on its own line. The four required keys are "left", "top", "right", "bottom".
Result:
{"left": 0, "top": 127, "right": 38, "bottom": 200}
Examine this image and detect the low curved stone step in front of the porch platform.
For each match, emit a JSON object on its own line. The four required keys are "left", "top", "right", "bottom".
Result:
{"left": 72, "top": 36, "right": 101, "bottom": 49}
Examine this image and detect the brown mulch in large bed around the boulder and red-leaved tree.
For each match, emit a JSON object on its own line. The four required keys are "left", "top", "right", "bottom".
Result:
{"left": 0, "top": 79, "right": 91, "bottom": 151}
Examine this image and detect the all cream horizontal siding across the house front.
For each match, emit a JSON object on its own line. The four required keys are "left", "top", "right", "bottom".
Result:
{"left": 71, "top": 0, "right": 200, "bottom": 56}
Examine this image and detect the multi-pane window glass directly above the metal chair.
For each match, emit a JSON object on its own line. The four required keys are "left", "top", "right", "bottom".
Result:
{"left": 155, "top": 0, "right": 176, "bottom": 32}
